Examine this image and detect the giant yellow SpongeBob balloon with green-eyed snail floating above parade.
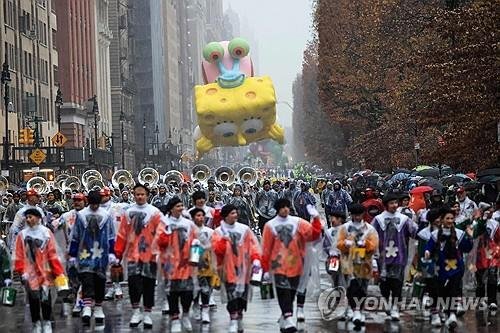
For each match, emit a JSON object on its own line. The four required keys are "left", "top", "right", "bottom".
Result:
{"left": 195, "top": 38, "right": 284, "bottom": 155}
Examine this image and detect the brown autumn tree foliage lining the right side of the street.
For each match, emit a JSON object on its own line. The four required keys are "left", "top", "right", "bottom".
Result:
{"left": 294, "top": 0, "right": 500, "bottom": 170}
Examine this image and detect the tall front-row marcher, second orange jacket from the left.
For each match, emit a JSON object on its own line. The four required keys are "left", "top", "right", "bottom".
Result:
{"left": 115, "top": 184, "right": 161, "bottom": 329}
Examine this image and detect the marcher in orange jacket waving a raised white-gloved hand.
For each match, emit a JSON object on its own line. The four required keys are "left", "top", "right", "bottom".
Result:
{"left": 260, "top": 199, "right": 322, "bottom": 333}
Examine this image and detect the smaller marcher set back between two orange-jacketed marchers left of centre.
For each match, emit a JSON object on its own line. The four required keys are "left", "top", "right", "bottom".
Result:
{"left": 190, "top": 208, "right": 218, "bottom": 324}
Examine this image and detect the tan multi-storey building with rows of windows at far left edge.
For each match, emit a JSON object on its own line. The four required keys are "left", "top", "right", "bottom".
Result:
{"left": 0, "top": 0, "right": 58, "bottom": 171}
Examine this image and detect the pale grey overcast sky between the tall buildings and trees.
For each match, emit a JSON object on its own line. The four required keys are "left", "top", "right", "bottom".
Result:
{"left": 224, "top": 0, "right": 312, "bottom": 127}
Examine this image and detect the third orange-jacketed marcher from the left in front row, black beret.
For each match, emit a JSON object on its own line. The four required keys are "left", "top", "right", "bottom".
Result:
{"left": 156, "top": 197, "right": 200, "bottom": 333}
